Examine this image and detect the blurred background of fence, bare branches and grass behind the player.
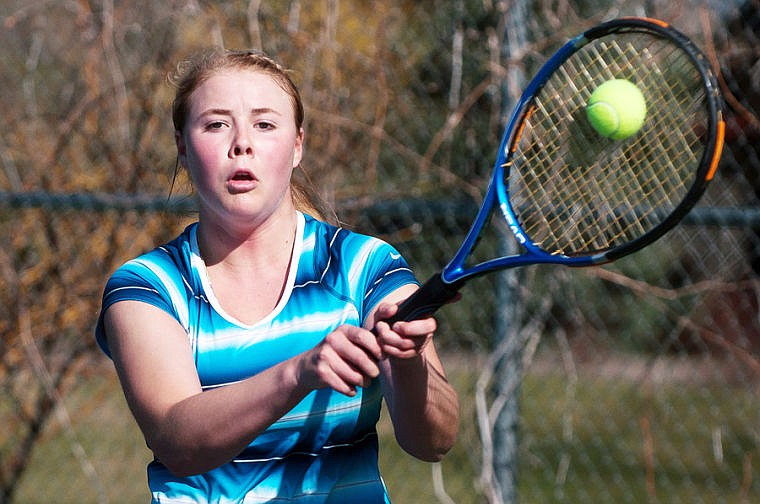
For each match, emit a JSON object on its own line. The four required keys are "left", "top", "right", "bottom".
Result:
{"left": 0, "top": 0, "right": 760, "bottom": 503}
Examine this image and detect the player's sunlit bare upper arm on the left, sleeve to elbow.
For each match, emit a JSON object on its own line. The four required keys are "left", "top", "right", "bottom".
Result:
{"left": 103, "top": 301, "right": 201, "bottom": 444}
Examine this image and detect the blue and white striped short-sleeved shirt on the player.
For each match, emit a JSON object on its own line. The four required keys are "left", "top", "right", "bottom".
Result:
{"left": 96, "top": 213, "right": 416, "bottom": 504}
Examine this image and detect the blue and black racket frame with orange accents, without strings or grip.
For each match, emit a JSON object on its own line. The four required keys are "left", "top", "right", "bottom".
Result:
{"left": 441, "top": 17, "right": 725, "bottom": 286}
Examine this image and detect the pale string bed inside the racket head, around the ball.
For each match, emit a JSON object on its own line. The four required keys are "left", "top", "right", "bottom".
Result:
{"left": 506, "top": 33, "right": 707, "bottom": 256}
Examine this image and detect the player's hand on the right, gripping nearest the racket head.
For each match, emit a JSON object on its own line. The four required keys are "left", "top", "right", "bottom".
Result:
{"left": 375, "top": 304, "right": 437, "bottom": 359}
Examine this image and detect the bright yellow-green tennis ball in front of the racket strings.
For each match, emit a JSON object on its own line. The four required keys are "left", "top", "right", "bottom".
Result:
{"left": 586, "top": 79, "right": 647, "bottom": 140}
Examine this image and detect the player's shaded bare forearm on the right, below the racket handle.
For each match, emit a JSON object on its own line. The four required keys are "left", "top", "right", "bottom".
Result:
{"left": 383, "top": 352, "right": 459, "bottom": 462}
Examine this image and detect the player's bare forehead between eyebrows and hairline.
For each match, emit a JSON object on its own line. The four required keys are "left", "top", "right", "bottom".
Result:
{"left": 189, "top": 69, "right": 292, "bottom": 113}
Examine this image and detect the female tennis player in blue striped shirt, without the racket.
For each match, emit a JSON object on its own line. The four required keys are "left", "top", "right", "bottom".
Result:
{"left": 96, "top": 51, "right": 458, "bottom": 504}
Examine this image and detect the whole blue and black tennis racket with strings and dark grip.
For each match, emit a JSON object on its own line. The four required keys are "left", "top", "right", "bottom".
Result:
{"left": 388, "top": 18, "right": 725, "bottom": 323}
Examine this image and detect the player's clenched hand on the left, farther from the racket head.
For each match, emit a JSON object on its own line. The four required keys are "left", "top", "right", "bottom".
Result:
{"left": 299, "top": 325, "right": 382, "bottom": 396}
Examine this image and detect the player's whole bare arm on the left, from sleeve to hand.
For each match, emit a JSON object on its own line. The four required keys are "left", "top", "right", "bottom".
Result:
{"left": 109, "top": 301, "right": 381, "bottom": 476}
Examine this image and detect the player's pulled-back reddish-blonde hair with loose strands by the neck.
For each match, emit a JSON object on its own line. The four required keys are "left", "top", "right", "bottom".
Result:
{"left": 170, "top": 49, "right": 327, "bottom": 220}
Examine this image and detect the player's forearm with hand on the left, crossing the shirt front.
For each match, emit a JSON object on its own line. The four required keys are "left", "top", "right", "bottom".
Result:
{"left": 143, "top": 325, "right": 381, "bottom": 474}
